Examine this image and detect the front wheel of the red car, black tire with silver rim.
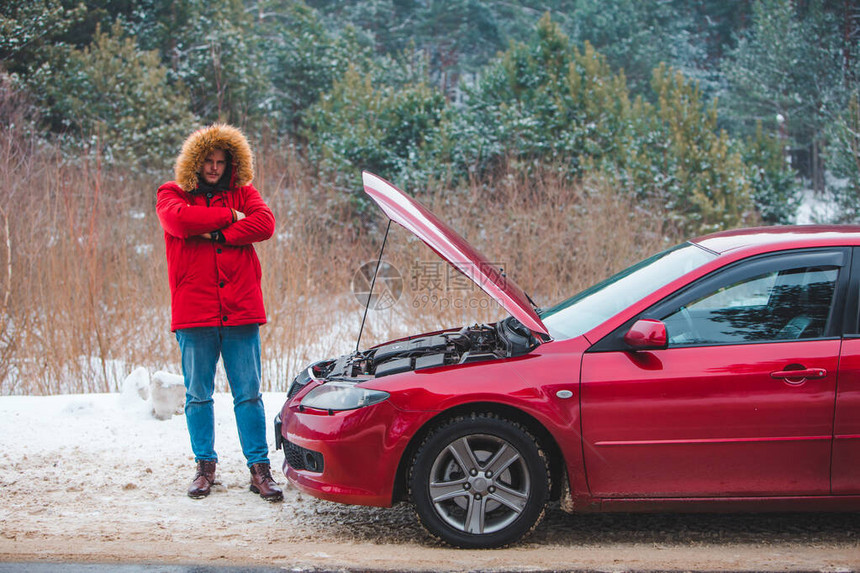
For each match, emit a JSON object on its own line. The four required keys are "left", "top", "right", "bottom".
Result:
{"left": 409, "top": 414, "right": 550, "bottom": 548}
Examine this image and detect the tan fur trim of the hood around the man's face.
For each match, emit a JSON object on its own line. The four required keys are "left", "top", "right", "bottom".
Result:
{"left": 173, "top": 123, "right": 254, "bottom": 191}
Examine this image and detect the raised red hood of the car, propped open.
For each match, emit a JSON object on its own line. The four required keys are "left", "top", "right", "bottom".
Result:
{"left": 361, "top": 171, "right": 549, "bottom": 338}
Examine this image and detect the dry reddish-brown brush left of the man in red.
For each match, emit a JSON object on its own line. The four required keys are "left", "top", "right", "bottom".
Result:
{"left": 0, "top": 134, "right": 173, "bottom": 393}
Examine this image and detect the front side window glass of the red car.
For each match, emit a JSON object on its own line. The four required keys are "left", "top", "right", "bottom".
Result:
{"left": 662, "top": 266, "right": 839, "bottom": 347}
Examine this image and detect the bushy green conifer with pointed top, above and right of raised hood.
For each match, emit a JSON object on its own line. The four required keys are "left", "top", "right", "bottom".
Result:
{"left": 455, "top": 16, "right": 629, "bottom": 175}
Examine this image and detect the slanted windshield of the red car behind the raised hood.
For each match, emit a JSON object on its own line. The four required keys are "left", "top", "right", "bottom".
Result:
{"left": 541, "top": 243, "right": 717, "bottom": 340}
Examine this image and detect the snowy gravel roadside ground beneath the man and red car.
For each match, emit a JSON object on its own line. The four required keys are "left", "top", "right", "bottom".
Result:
{"left": 0, "top": 395, "right": 860, "bottom": 571}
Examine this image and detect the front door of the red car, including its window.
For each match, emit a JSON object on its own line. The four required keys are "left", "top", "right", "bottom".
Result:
{"left": 581, "top": 249, "right": 850, "bottom": 497}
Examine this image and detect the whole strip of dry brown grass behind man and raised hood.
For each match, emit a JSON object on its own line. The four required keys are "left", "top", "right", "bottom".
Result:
{"left": 0, "top": 116, "right": 674, "bottom": 395}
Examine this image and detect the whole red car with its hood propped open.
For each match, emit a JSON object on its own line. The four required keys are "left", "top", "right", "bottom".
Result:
{"left": 275, "top": 173, "right": 860, "bottom": 547}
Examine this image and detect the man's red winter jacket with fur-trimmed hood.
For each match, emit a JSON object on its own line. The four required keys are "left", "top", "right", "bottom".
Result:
{"left": 156, "top": 124, "right": 275, "bottom": 330}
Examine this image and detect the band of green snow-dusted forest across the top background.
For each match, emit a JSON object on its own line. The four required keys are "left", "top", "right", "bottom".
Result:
{"left": 5, "top": 0, "right": 860, "bottom": 232}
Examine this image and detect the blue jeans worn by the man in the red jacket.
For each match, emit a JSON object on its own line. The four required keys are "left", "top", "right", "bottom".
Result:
{"left": 176, "top": 324, "right": 269, "bottom": 467}
